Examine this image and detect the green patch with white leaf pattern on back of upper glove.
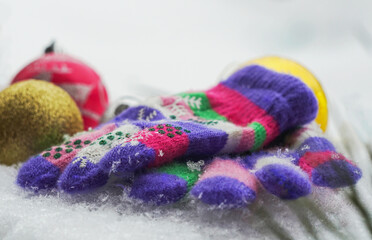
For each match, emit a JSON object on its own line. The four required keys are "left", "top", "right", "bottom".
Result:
{"left": 179, "top": 92, "right": 227, "bottom": 121}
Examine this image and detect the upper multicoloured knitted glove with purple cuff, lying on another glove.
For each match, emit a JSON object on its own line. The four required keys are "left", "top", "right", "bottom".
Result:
{"left": 18, "top": 66, "right": 316, "bottom": 192}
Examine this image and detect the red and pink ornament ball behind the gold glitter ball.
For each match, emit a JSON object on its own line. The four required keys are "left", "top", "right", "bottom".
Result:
{"left": 12, "top": 51, "right": 108, "bottom": 129}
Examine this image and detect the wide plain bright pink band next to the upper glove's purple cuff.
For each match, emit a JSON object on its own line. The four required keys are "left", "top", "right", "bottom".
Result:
{"left": 206, "top": 84, "right": 279, "bottom": 145}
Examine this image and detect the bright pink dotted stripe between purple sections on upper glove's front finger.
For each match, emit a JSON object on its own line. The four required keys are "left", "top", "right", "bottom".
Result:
{"left": 131, "top": 124, "right": 189, "bottom": 167}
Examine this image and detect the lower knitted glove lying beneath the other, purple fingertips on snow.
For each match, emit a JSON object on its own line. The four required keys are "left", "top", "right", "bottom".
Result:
{"left": 130, "top": 123, "right": 361, "bottom": 207}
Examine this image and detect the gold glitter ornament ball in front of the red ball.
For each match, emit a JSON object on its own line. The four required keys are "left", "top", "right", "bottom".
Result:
{"left": 0, "top": 80, "right": 83, "bottom": 165}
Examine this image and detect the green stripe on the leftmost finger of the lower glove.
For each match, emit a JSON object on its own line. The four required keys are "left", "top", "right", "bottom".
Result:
{"left": 156, "top": 162, "right": 200, "bottom": 190}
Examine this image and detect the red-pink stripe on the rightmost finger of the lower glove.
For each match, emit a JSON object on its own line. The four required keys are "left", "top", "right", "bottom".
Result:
{"left": 298, "top": 151, "right": 354, "bottom": 177}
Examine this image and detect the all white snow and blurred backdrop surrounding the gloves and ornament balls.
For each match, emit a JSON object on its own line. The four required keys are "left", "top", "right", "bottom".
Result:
{"left": 0, "top": 0, "right": 372, "bottom": 240}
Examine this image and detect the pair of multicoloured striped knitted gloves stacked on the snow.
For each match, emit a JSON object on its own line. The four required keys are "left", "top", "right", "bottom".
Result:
{"left": 17, "top": 63, "right": 361, "bottom": 207}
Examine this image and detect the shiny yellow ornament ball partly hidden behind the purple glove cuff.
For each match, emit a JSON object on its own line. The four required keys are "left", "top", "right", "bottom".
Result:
{"left": 241, "top": 56, "right": 328, "bottom": 131}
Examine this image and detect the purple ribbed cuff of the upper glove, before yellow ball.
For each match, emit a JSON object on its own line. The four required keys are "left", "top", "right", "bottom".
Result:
{"left": 222, "top": 65, "right": 318, "bottom": 132}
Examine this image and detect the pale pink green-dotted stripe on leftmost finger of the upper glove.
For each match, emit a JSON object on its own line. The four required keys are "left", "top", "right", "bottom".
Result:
{"left": 40, "top": 123, "right": 116, "bottom": 171}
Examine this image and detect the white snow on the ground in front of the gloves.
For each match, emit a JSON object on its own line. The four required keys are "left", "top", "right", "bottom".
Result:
{"left": 0, "top": 161, "right": 371, "bottom": 240}
